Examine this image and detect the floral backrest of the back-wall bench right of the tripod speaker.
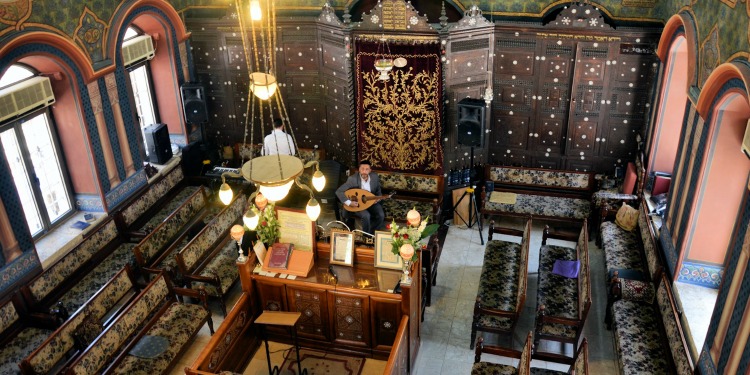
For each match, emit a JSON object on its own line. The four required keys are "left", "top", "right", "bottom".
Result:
{"left": 489, "top": 165, "right": 593, "bottom": 190}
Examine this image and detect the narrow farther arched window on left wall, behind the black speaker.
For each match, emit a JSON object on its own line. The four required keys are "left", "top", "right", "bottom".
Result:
{"left": 123, "top": 27, "right": 158, "bottom": 155}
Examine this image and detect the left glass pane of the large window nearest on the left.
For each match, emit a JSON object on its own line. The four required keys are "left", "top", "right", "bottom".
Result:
{"left": 0, "top": 129, "right": 42, "bottom": 236}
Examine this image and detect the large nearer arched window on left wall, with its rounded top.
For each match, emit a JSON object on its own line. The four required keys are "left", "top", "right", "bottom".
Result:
{"left": 0, "top": 64, "right": 75, "bottom": 237}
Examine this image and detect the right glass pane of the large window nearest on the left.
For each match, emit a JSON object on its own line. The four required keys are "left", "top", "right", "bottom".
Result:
{"left": 21, "top": 113, "right": 72, "bottom": 222}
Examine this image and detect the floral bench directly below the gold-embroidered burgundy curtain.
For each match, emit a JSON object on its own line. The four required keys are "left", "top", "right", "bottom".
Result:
{"left": 373, "top": 171, "right": 444, "bottom": 223}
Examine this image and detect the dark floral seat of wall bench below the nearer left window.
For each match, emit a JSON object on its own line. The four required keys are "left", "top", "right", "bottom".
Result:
{"left": 60, "top": 243, "right": 136, "bottom": 314}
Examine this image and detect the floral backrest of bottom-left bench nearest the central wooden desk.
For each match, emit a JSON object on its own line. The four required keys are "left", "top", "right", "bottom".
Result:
{"left": 70, "top": 276, "right": 169, "bottom": 375}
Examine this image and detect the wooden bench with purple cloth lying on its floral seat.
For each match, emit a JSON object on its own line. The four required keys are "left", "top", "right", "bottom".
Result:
{"left": 534, "top": 219, "right": 591, "bottom": 347}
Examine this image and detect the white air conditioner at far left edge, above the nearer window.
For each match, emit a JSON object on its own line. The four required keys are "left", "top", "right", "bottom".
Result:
{"left": 0, "top": 77, "right": 55, "bottom": 122}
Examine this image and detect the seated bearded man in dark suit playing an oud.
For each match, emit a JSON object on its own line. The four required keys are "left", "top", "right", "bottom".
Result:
{"left": 336, "top": 160, "right": 385, "bottom": 234}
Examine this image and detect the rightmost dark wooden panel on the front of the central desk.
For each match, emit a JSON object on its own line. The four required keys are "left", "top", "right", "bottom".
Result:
{"left": 370, "top": 298, "right": 406, "bottom": 352}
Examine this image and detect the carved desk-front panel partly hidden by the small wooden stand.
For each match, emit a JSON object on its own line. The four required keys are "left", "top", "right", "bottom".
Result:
{"left": 287, "top": 286, "right": 330, "bottom": 341}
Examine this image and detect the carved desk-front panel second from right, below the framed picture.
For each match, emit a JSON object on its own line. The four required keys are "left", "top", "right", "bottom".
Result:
{"left": 329, "top": 291, "right": 370, "bottom": 347}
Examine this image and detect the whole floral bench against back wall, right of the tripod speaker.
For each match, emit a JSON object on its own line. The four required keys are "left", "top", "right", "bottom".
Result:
{"left": 481, "top": 165, "right": 596, "bottom": 221}
